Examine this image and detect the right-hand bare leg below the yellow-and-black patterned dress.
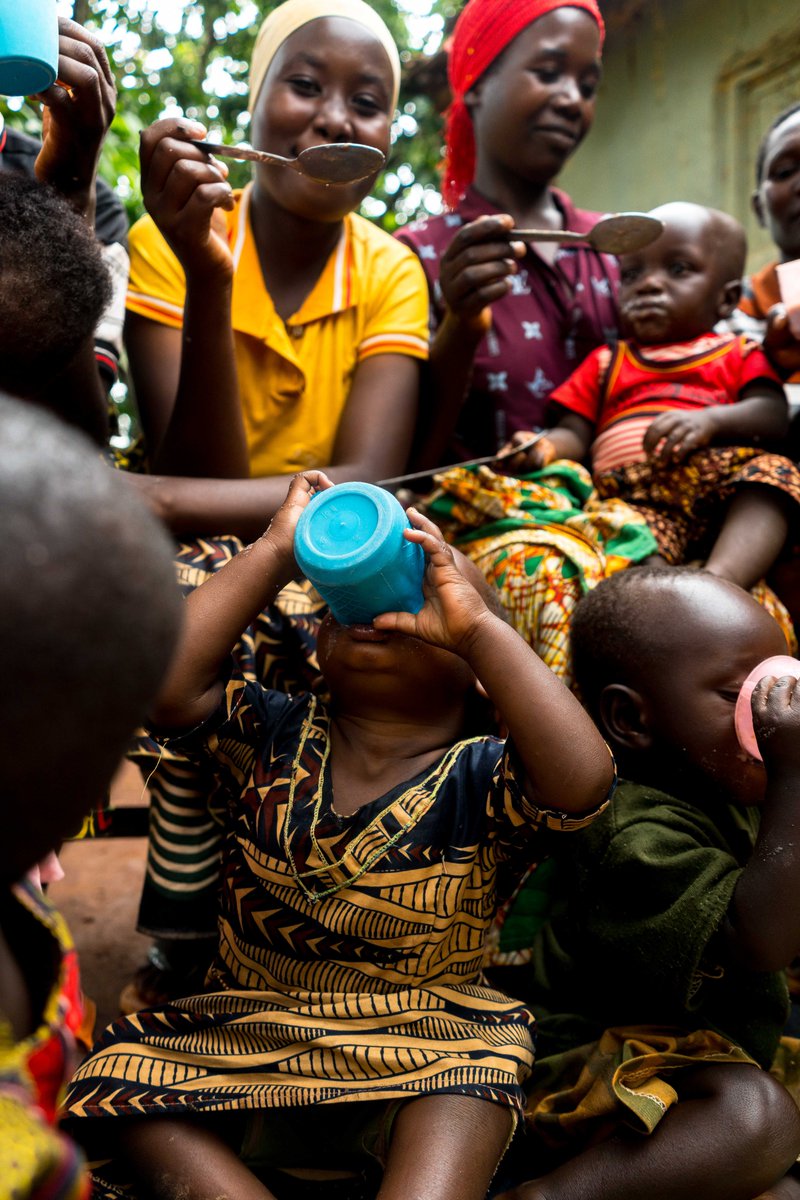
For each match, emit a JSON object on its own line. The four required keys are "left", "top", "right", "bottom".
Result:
{"left": 378, "top": 1096, "right": 515, "bottom": 1200}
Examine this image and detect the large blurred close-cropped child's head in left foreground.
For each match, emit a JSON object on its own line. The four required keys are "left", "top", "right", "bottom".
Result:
{"left": 0, "top": 394, "right": 180, "bottom": 864}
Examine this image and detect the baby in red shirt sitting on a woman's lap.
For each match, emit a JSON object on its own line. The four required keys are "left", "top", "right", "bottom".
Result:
{"left": 513, "top": 203, "right": 800, "bottom": 588}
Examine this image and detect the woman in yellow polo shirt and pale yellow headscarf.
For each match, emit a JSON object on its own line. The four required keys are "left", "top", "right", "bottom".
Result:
{"left": 127, "top": 0, "right": 428, "bottom": 536}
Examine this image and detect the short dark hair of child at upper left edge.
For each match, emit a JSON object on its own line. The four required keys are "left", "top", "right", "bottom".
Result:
{"left": 0, "top": 172, "right": 112, "bottom": 396}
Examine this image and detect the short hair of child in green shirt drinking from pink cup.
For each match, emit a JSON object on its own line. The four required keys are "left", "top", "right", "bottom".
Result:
{"left": 570, "top": 566, "right": 717, "bottom": 721}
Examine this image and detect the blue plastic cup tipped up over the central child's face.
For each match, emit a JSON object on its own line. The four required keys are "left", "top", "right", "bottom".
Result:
{"left": 295, "top": 484, "right": 425, "bottom": 625}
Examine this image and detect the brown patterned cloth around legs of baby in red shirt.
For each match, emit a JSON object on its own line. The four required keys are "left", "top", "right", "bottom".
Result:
{"left": 595, "top": 446, "right": 800, "bottom": 565}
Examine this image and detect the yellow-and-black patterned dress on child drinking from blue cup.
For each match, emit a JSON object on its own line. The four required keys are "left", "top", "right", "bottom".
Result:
{"left": 67, "top": 678, "right": 606, "bottom": 1128}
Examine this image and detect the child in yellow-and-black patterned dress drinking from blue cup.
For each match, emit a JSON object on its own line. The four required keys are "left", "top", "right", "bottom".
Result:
{"left": 68, "top": 472, "right": 613, "bottom": 1200}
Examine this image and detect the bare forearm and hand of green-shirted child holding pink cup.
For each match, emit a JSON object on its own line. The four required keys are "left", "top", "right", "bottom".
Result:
{"left": 722, "top": 676, "right": 800, "bottom": 971}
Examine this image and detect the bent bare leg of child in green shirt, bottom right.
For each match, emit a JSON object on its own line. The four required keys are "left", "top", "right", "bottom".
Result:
{"left": 498, "top": 1064, "right": 800, "bottom": 1200}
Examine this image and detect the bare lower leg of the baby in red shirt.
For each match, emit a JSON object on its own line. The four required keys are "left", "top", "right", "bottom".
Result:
{"left": 705, "top": 487, "right": 789, "bottom": 590}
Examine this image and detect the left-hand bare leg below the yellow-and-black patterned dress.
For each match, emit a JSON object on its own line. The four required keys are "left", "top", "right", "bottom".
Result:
{"left": 112, "top": 1117, "right": 275, "bottom": 1200}
